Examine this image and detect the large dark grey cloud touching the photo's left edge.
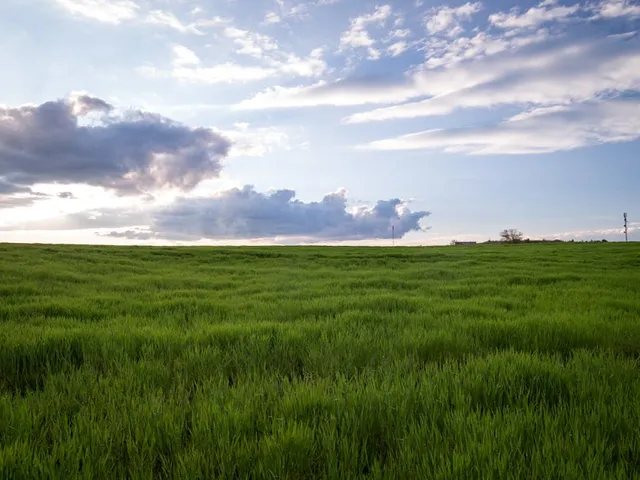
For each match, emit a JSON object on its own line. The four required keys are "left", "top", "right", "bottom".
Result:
{"left": 0, "top": 95, "right": 230, "bottom": 194}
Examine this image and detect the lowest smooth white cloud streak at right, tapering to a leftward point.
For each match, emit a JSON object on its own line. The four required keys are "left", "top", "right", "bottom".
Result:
{"left": 361, "top": 98, "right": 640, "bottom": 155}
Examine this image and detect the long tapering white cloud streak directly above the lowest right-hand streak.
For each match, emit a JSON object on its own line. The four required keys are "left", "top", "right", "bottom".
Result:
{"left": 345, "top": 29, "right": 640, "bottom": 123}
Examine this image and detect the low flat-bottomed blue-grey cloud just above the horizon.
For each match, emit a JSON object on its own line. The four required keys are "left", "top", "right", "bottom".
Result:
{"left": 106, "top": 186, "right": 429, "bottom": 240}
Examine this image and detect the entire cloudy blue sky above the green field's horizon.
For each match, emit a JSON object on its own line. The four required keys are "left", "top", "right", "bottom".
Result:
{"left": 0, "top": 0, "right": 640, "bottom": 245}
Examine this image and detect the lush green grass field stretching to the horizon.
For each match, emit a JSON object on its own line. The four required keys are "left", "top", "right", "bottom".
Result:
{"left": 0, "top": 243, "right": 640, "bottom": 479}
